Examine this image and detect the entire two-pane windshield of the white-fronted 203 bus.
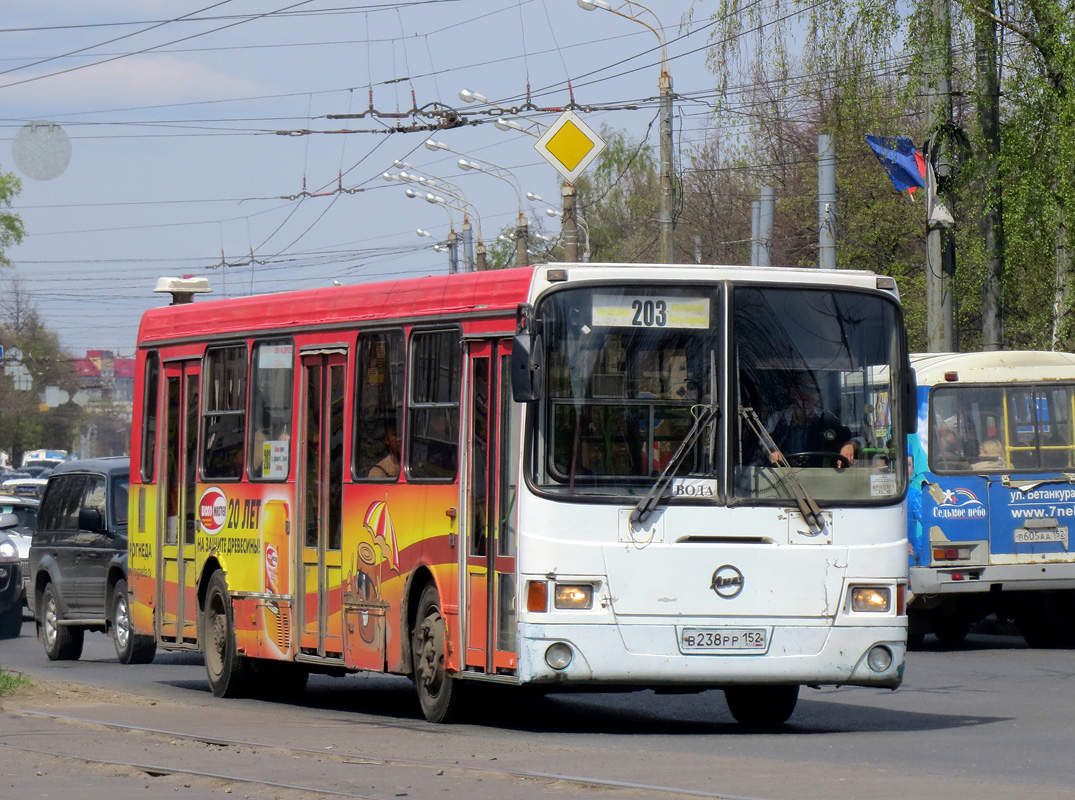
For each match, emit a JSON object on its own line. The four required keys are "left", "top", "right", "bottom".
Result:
{"left": 533, "top": 285, "right": 906, "bottom": 503}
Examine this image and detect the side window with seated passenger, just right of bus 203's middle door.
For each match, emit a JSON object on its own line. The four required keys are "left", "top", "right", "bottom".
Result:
{"left": 352, "top": 330, "right": 405, "bottom": 481}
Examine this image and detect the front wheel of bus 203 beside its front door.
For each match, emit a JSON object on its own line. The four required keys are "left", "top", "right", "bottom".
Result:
{"left": 411, "top": 584, "right": 462, "bottom": 723}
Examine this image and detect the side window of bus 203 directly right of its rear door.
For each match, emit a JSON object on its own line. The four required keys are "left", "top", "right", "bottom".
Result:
{"left": 202, "top": 344, "right": 246, "bottom": 480}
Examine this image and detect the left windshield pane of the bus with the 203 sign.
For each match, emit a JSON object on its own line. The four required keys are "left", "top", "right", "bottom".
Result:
{"left": 536, "top": 286, "right": 720, "bottom": 496}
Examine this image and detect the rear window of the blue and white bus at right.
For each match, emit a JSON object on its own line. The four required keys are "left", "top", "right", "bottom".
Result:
{"left": 929, "top": 384, "right": 1075, "bottom": 473}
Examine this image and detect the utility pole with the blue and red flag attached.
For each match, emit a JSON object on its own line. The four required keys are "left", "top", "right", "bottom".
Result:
{"left": 926, "top": 0, "right": 956, "bottom": 353}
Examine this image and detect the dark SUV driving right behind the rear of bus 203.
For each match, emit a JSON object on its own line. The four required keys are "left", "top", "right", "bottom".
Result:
{"left": 27, "top": 456, "right": 157, "bottom": 663}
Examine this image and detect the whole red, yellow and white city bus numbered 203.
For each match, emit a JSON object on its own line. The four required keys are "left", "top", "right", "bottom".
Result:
{"left": 129, "top": 263, "right": 916, "bottom": 726}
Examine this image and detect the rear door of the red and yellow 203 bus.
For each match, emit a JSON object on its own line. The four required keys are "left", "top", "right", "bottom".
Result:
{"left": 156, "top": 361, "right": 201, "bottom": 647}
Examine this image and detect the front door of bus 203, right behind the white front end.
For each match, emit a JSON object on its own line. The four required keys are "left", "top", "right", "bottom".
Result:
{"left": 463, "top": 341, "right": 520, "bottom": 674}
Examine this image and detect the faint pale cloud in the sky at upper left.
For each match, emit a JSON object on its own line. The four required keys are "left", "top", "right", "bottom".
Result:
{"left": 0, "top": 56, "right": 264, "bottom": 114}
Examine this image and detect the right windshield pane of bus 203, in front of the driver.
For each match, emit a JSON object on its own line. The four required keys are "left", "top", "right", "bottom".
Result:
{"left": 732, "top": 287, "right": 906, "bottom": 503}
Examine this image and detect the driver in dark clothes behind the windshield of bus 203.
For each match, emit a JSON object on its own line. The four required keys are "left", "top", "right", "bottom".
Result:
{"left": 765, "top": 374, "right": 861, "bottom": 467}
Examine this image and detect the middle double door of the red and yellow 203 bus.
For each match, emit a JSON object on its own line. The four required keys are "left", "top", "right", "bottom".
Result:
{"left": 298, "top": 349, "right": 346, "bottom": 658}
